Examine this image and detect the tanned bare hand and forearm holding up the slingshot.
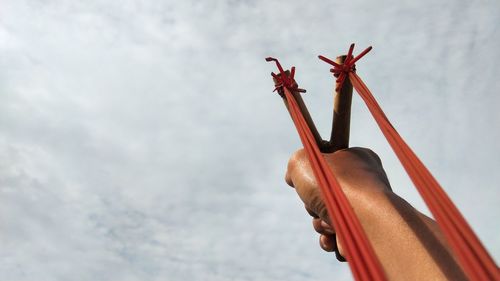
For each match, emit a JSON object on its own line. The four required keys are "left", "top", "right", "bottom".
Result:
{"left": 285, "top": 148, "right": 467, "bottom": 281}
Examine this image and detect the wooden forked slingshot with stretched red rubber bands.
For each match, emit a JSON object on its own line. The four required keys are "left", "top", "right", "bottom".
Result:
{"left": 266, "top": 44, "right": 500, "bottom": 280}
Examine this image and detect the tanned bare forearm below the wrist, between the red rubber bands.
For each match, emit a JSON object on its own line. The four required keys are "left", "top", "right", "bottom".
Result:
{"left": 348, "top": 191, "right": 466, "bottom": 280}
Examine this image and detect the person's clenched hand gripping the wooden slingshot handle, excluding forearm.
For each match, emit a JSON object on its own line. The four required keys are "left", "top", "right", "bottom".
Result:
{"left": 285, "top": 148, "right": 391, "bottom": 261}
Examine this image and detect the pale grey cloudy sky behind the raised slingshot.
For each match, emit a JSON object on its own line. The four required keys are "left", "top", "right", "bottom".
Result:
{"left": 0, "top": 0, "right": 500, "bottom": 281}
